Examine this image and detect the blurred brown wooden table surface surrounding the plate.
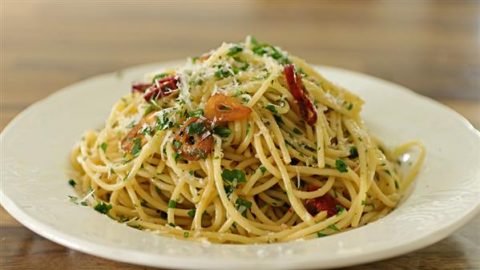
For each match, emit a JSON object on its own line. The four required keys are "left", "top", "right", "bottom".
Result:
{"left": 0, "top": 0, "right": 480, "bottom": 270}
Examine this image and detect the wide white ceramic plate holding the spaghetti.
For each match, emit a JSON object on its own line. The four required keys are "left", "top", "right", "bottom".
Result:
{"left": 0, "top": 62, "right": 480, "bottom": 269}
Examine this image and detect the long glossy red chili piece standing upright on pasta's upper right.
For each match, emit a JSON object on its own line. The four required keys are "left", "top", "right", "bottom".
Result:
{"left": 283, "top": 64, "right": 317, "bottom": 126}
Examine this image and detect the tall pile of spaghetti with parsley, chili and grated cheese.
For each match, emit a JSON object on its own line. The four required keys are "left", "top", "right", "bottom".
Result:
{"left": 71, "top": 37, "right": 424, "bottom": 243}
